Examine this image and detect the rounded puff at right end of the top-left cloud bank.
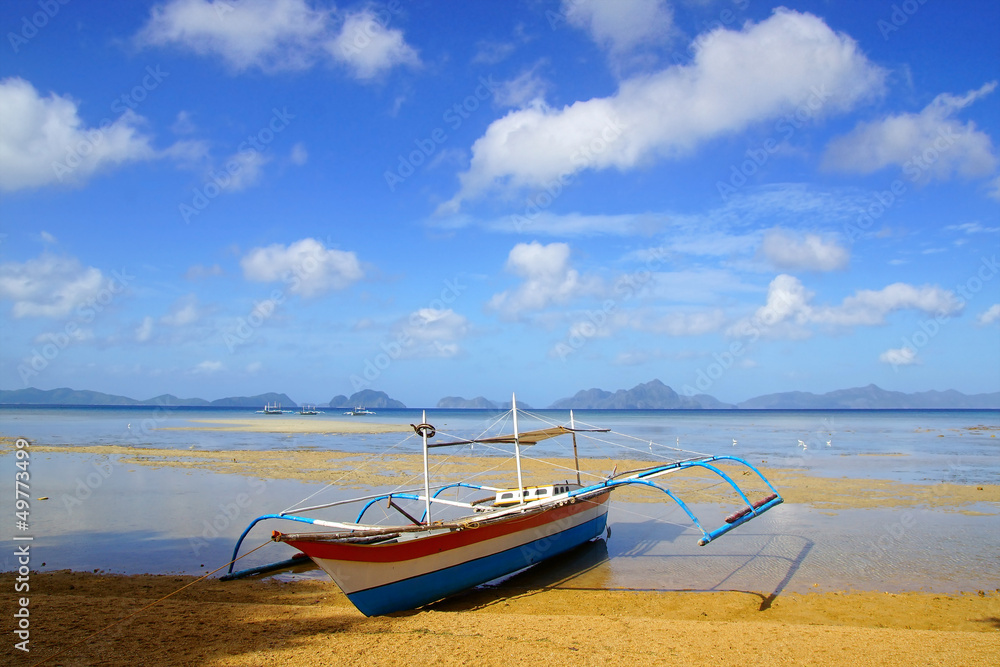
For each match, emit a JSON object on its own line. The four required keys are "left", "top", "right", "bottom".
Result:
{"left": 326, "top": 9, "right": 420, "bottom": 79}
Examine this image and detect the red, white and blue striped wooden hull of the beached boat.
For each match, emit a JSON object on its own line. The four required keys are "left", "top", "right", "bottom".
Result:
{"left": 282, "top": 490, "right": 611, "bottom": 616}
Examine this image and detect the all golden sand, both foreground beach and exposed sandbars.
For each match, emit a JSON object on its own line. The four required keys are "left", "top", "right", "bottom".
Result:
{"left": 0, "top": 418, "right": 1000, "bottom": 666}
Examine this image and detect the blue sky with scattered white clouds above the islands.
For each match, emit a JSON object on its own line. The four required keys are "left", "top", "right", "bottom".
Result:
{"left": 0, "top": 0, "right": 1000, "bottom": 406}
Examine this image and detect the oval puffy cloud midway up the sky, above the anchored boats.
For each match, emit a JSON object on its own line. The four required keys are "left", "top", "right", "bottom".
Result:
{"left": 240, "top": 238, "right": 364, "bottom": 297}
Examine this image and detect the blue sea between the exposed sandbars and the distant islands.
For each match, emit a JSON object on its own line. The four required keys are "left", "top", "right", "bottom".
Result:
{"left": 0, "top": 406, "right": 1000, "bottom": 484}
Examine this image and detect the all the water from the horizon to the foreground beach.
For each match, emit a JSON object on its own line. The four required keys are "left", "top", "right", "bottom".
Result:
{"left": 0, "top": 406, "right": 1000, "bottom": 596}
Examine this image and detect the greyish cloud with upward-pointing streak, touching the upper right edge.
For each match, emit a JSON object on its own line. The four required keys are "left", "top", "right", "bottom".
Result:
{"left": 822, "top": 81, "right": 997, "bottom": 182}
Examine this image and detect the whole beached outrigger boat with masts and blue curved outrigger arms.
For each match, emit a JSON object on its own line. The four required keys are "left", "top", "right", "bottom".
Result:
{"left": 225, "top": 394, "right": 782, "bottom": 616}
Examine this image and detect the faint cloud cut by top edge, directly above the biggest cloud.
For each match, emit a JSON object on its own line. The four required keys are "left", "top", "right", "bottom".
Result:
{"left": 562, "top": 0, "right": 673, "bottom": 55}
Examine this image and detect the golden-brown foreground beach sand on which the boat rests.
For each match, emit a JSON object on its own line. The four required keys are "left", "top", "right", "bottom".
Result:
{"left": 7, "top": 572, "right": 1000, "bottom": 667}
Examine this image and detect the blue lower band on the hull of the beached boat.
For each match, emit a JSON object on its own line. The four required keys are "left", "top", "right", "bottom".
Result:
{"left": 347, "top": 513, "right": 608, "bottom": 616}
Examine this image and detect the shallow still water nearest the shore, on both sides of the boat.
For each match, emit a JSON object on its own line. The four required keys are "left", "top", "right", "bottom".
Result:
{"left": 0, "top": 454, "right": 1000, "bottom": 596}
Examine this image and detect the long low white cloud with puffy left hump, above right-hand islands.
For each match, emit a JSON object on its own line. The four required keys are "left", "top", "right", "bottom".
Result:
{"left": 728, "top": 274, "right": 963, "bottom": 338}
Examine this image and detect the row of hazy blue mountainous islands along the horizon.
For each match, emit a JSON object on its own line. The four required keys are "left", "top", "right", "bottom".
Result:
{"left": 0, "top": 380, "right": 1000, "bottom": 410}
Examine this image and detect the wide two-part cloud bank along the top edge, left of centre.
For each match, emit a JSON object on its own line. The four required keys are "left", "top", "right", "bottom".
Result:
{"left": 135, "top": 0, "right": 420, "bottom": 79}
